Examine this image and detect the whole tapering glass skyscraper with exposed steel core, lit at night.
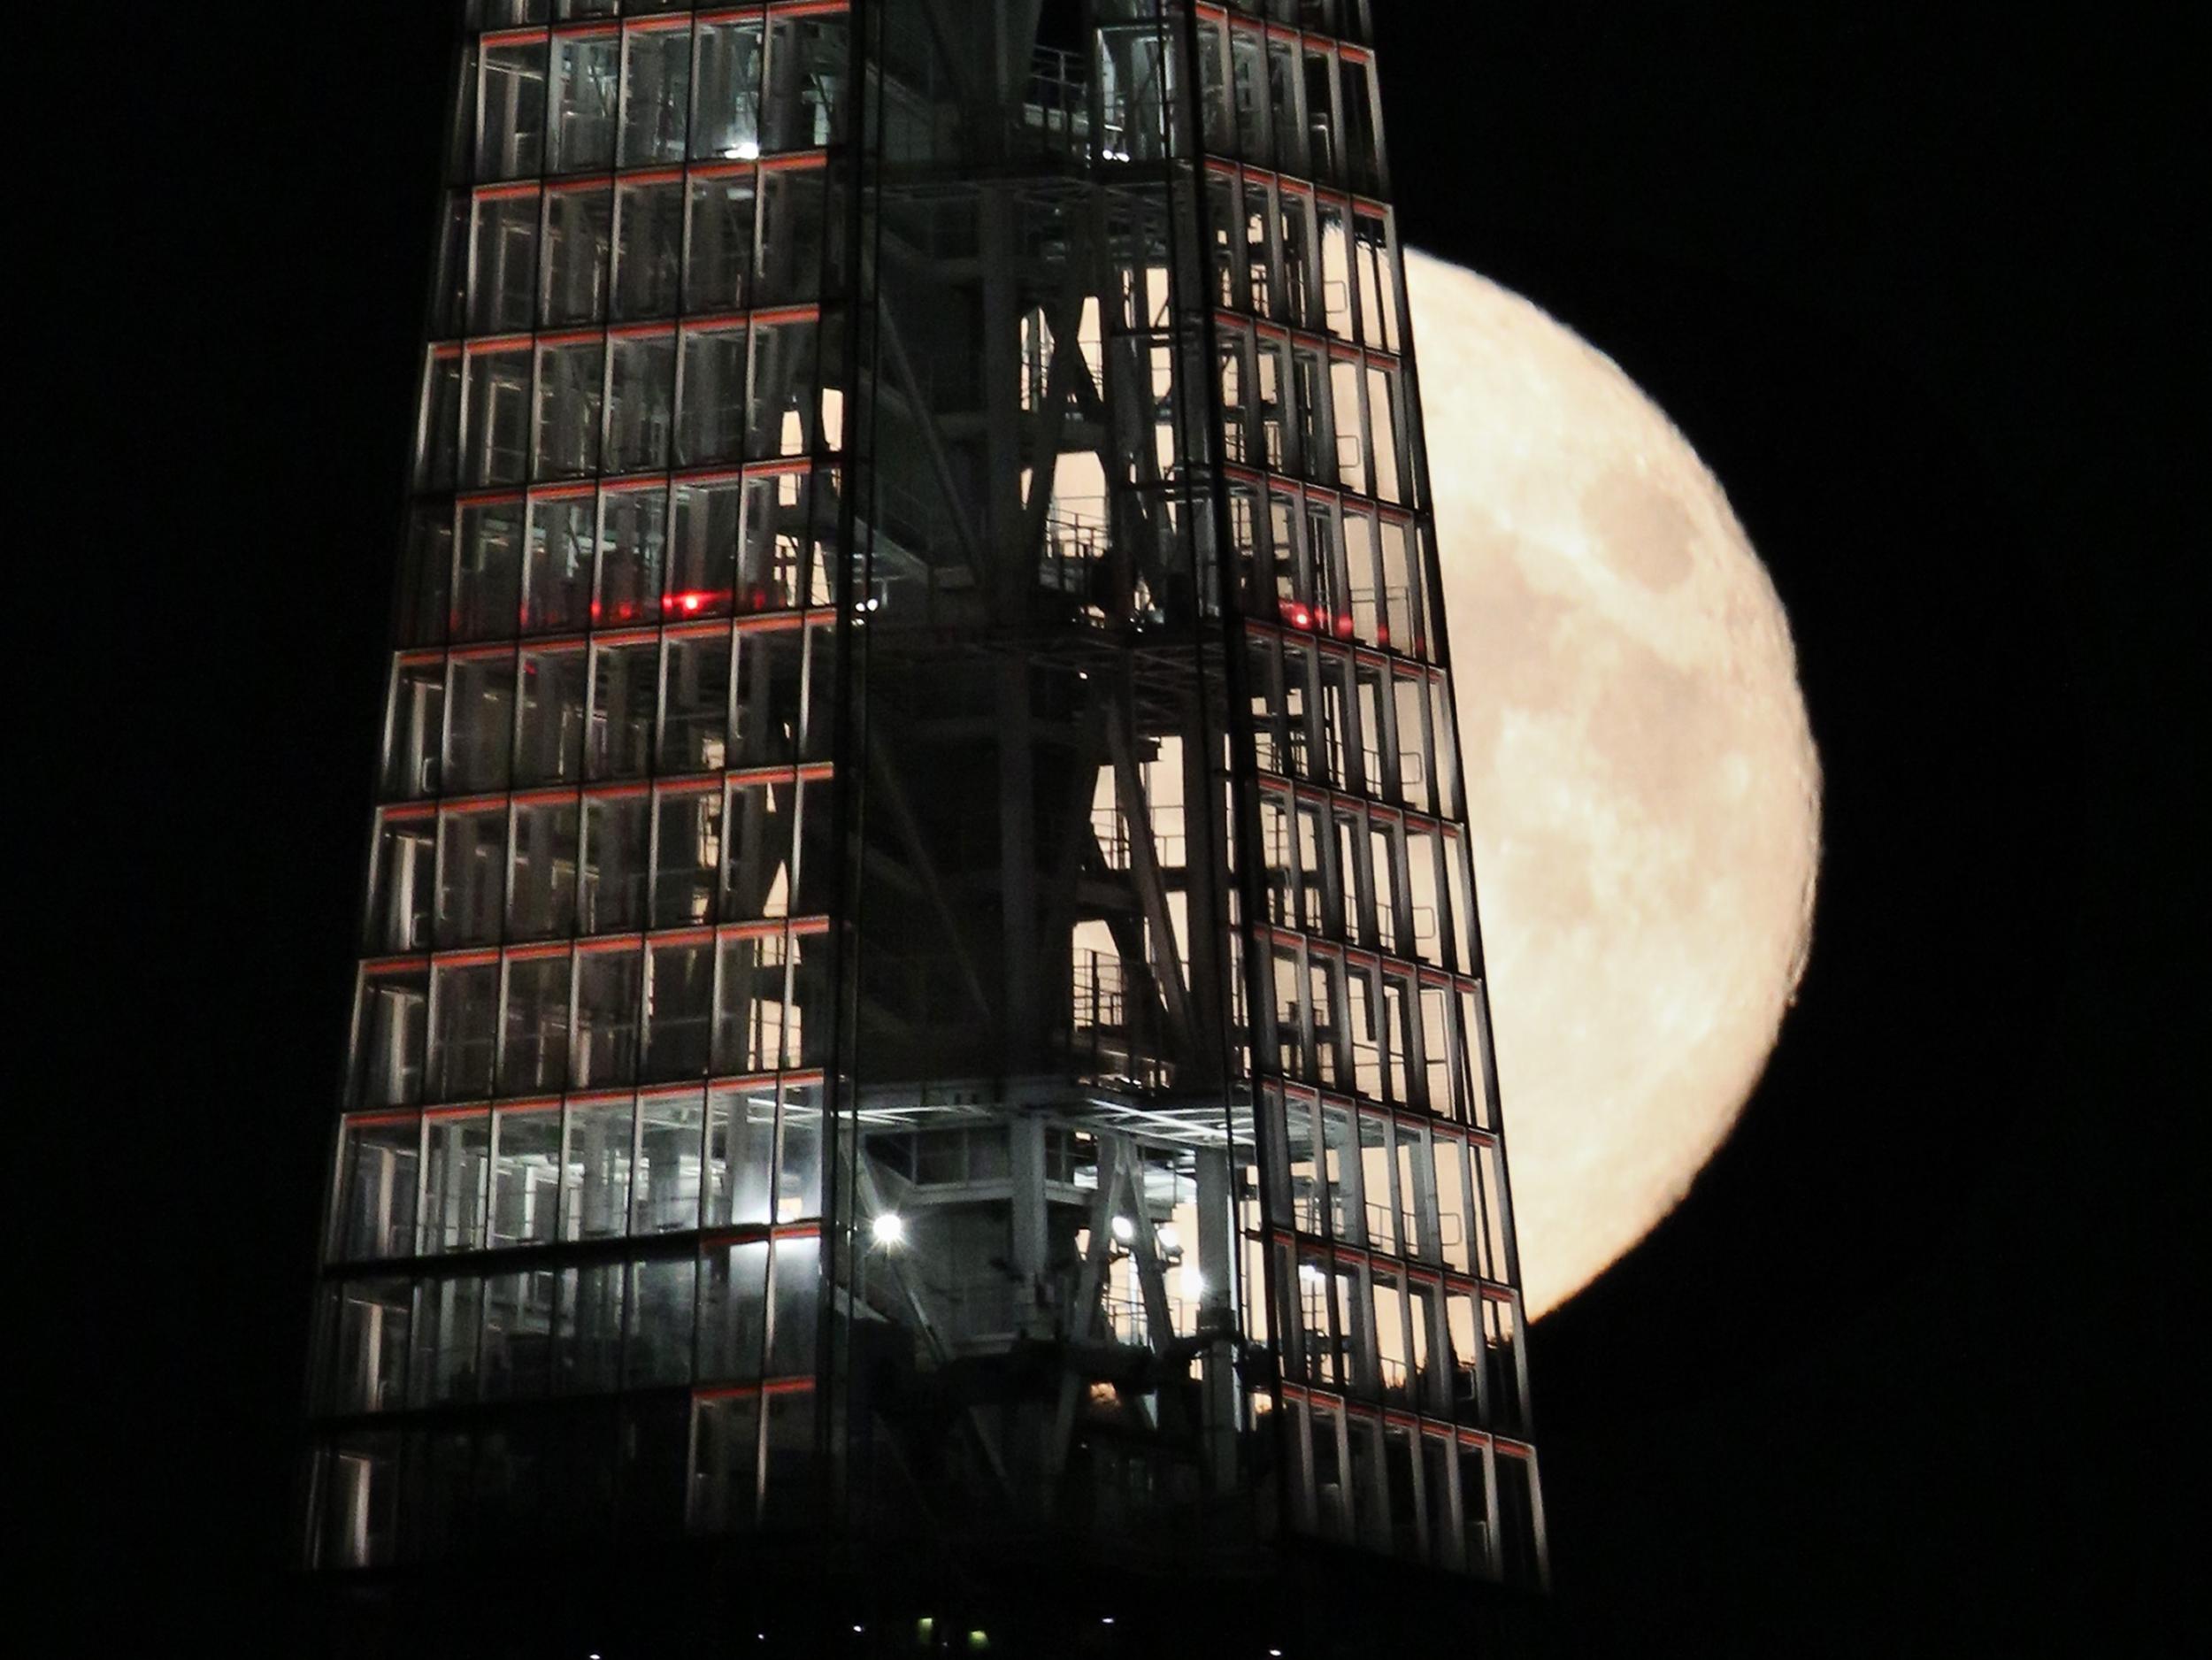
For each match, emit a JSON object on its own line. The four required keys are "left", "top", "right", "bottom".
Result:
{"left": 303, "top": 0, "right": 1544, "bottom": 1610}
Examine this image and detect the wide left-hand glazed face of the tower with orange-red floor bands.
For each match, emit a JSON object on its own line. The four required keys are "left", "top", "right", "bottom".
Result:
{"left": 308, "top": 0, "right": 849, "bottom": 1567}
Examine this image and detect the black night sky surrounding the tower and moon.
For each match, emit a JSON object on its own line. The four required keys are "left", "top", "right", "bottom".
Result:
{"left": 60, "top": 0, "right": 2206, "bottom": 1656}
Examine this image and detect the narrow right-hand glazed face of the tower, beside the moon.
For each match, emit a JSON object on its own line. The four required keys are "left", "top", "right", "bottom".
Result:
{"left": 1194, "top": 0, "right": 1542, "bottom": 1582}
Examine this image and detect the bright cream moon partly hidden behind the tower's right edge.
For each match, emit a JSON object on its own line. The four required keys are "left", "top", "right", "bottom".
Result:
{"left": 1405, "top": 252, "right": 1821, "bottom": 1317}
